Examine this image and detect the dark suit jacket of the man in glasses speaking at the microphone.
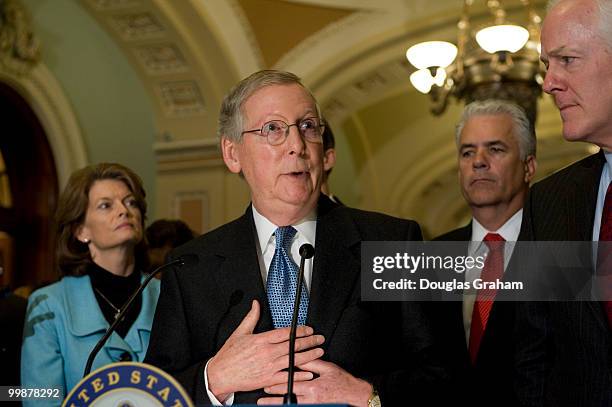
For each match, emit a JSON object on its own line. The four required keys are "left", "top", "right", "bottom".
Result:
{"left": 146, "top": 195, "right": 444, "bottom": 406}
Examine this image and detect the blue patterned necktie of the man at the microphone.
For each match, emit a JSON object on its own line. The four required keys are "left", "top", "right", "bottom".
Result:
{"left": 267, "top": 226, "right": 308, "bottom": 328}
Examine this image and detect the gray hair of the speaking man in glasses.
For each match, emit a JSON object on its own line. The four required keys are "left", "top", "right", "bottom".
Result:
{"left": 217, "top": 70, "right": 321, "bottom": 143}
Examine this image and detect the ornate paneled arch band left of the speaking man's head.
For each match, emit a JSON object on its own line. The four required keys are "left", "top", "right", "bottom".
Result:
{"left": 80, "top": 0, "right": 237, "bottom": 145}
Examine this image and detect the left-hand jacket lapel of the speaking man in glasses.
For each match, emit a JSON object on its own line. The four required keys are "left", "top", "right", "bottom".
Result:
{"left": 213, "top": 206, "right": 274, "bottom": 341}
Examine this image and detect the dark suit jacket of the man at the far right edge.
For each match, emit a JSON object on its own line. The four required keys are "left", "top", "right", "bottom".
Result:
{"left": 516, "top": 151, "right": 612, "bottom": 407}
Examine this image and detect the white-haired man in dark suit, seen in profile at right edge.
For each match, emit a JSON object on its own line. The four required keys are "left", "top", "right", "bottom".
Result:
{"left": 516, "top": 0, "right": 612, "bottom": 407}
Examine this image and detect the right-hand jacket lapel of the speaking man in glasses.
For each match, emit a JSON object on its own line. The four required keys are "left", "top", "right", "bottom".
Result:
{"left": 306, "top": 195, "right": 361, "bottom": 341}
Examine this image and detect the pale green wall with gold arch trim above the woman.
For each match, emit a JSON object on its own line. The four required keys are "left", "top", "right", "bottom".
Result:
{"left": 20, "top": 0, "right": 156, "bottom": 213}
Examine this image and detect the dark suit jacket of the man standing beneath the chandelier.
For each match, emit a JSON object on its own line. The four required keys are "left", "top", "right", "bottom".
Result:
{"left": 430, "top": 223, "right": 517, "bottom": 406}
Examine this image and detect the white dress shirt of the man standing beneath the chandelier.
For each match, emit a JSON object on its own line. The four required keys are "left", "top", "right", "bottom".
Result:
{"left": 463, "top": 209, "right": 523, "bottom": 343}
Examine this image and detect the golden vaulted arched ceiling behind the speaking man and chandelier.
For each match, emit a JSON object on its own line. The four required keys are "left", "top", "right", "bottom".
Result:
{"left": 68, "top": 0, "right": 589, "bottom": 236}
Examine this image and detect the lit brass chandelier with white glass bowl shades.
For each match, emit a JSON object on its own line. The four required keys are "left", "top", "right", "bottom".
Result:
{"left": 406, "top": 0, "right": 543, "bottom": 124}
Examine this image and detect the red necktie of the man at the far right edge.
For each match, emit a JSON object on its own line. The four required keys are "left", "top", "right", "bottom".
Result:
{"left": 597, "top": 183, "right": 612, "bottom": 327}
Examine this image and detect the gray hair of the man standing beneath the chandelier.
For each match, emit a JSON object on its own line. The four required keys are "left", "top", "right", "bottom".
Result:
{"left": 455, "top": 99, "right": 536, "bottom": 160}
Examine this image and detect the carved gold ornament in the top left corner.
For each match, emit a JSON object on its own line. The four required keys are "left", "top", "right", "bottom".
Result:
{"left": 0, "top": 0, "right": 40, "bottom": 75}
